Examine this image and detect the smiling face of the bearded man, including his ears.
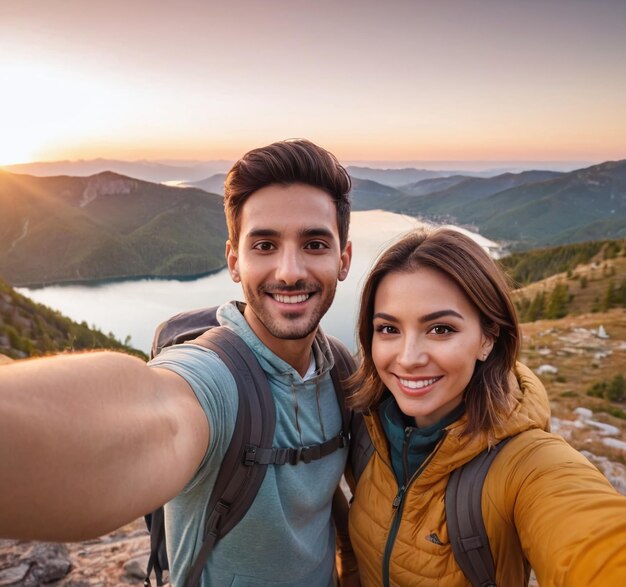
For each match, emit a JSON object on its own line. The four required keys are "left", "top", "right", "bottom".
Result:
{"left": 226, "top": 184, "right": 352, "bottom": 349}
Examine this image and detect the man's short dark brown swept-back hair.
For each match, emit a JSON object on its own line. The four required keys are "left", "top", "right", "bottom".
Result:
{"left": 224, "top": 139, "right": 351, "bottom": 250}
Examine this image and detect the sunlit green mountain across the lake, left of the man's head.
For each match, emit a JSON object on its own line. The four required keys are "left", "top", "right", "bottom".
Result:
{"left": 0, "top": 172, "right": 227, "bottom": 285}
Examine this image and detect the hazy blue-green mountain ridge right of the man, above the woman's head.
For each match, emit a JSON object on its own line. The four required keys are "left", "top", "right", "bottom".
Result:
{"left": 346, "top": 160, "right": 626, "bottom": 250}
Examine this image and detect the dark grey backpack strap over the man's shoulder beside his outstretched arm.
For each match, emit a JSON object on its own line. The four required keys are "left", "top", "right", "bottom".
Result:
{"left": 185, "top": 327, "right": 276, "bottom": 587}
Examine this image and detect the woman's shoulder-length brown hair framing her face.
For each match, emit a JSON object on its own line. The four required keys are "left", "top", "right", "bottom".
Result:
{"left": 348, "top": 229, "right": 520, "bottom": 435}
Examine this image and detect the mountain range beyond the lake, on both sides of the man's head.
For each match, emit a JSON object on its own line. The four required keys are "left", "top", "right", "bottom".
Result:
{"left": 0, "top": 160, "right": 626, "bottom": 285}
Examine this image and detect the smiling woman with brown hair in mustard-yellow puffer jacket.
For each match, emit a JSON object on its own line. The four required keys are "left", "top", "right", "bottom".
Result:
{"left": 350, "top": 230, "right": 626, "bottom": 587}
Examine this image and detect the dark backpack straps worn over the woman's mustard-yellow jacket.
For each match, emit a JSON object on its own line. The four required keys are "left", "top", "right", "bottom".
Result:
{"left": 348, "top": 422, "right": 511, "bottom": 587}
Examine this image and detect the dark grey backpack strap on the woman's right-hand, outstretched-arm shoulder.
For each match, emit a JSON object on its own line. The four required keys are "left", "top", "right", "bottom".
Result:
{"left": 445, "top": 438, "right": 510, "bottom": 587}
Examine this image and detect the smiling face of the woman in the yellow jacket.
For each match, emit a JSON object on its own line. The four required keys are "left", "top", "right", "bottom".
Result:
{"left": 372, "top": 268, "right": 493, "bottom": 427}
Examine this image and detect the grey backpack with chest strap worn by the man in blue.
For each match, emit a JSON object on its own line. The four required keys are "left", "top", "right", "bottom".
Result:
{"left": 144, "top": 307, "right": 355, "bottom": 587}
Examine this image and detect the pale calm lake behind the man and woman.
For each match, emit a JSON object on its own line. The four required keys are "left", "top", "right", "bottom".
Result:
{"left": 16, "top": 210, "right": 496, "bottom": 352}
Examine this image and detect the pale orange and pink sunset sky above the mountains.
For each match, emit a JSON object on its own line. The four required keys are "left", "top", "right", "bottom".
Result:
{"left": 0, "top": 0, "right": 626, "bottom": 165}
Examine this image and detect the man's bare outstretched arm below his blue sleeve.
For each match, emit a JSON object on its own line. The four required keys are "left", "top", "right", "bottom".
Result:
{"left": 0, "top": 352, "right": 209, "bottom": 541}
